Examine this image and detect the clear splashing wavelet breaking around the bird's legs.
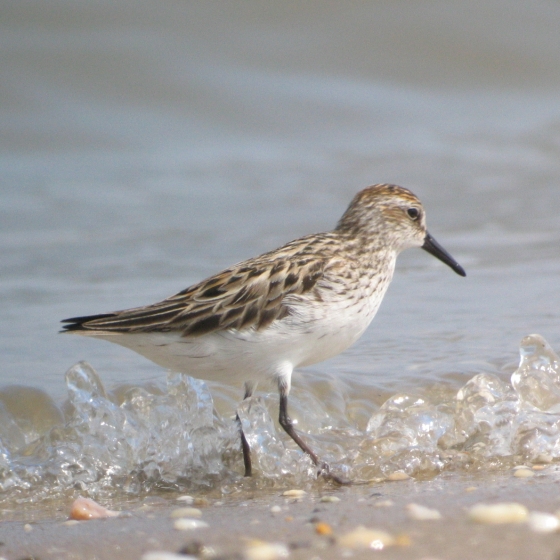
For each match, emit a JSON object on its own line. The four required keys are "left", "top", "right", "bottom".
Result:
{"left": 0, "top": 335, "right": 560, "bottom": 503}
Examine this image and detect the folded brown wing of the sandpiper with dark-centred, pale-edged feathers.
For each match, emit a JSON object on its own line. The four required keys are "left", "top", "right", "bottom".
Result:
{"left": 63, "top": 244, "right": 329, "bottom": 336}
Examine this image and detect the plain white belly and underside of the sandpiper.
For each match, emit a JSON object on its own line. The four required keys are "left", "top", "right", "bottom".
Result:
{"left": 73, "top": 260, "right": 391, "bottom": 386}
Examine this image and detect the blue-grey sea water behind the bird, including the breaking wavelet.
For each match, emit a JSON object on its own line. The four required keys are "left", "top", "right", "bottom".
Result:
{"left": 0, "top": 0, "right": 560, "bottom": 506}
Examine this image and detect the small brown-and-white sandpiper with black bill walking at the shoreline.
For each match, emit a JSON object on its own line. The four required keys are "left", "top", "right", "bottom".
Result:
{"left": 63, "top": 184, "right": 466, "bottom": 480}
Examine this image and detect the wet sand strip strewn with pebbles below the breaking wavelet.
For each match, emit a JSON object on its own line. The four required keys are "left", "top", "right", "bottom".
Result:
{"left": 0, "top": 467, "right": 560, "bottom": 560}
